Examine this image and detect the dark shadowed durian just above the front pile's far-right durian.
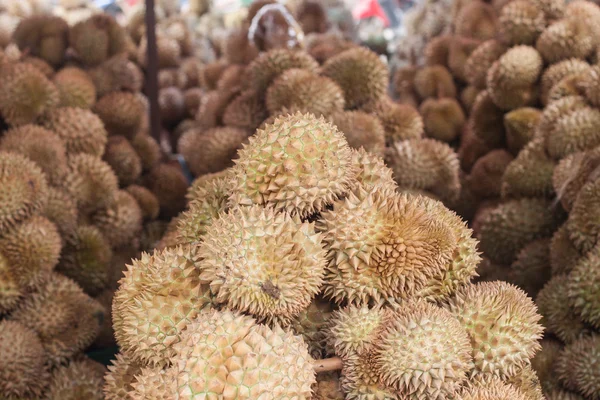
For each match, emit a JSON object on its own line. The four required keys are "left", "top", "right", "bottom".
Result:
{"left": 510, "top": 238, "right": 552, "bottom": 298}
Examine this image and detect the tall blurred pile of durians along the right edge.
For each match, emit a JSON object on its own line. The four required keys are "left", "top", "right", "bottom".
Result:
{"left": 397, "top": 0, "right": 600, "bottom": 400}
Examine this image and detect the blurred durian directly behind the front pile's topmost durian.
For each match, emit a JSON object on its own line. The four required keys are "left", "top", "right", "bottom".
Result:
{"left": 265, "top": 69, "right": 345, "bottom": 116}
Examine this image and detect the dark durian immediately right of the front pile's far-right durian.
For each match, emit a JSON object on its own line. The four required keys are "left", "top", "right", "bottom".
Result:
{"left": 535, "top": 275, "right": 589, "bottom": 343}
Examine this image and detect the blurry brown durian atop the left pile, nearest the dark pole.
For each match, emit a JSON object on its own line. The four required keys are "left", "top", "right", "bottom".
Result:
{"left": 69, "top": 14, "right": 127, "bottom": 67}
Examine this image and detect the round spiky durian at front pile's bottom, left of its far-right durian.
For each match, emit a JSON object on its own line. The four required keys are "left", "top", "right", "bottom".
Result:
{"left": 376, "top": 300, "right": 472, "bottom": 399}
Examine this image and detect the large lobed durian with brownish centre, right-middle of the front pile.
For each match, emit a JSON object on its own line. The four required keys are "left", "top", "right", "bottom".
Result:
{"left": 317, "top": 188, "right": 457, "bottom": 305}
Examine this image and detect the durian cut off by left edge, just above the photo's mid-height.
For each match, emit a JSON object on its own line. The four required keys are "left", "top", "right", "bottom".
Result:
{"left": 0, "top": 151, "right": 48, "bottom": 232}
